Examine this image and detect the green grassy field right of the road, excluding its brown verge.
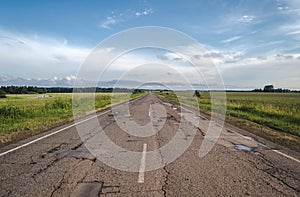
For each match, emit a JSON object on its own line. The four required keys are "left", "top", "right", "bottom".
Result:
{"left": 158, "top": 92, "right": 300, "bottom": 146}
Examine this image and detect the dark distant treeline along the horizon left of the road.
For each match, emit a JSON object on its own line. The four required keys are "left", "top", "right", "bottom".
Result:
{"left": 0, "top": 86, "right": 145, "bottom": 94}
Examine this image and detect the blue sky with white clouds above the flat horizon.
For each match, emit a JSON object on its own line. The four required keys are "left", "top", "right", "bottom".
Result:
{"left": 0, "top": 0, "right": 300, "bottom": 90}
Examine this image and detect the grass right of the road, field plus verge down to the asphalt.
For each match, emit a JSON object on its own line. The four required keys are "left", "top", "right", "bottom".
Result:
{"left": 156, "top": 92, "right": 300, "bottom": 151}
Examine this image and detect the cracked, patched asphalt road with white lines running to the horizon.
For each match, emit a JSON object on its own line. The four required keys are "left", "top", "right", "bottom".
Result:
{"left": 0, "top": 94, "right": 300, "bottom": 196}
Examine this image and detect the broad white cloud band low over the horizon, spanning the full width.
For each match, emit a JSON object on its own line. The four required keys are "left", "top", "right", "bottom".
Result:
{"left": 0, "top": 30, "right": 300, "bottom": 89}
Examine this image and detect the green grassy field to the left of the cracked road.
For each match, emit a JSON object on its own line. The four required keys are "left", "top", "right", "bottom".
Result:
{"left": 0, "top": 93, "right": 141, "bottom": 144}
